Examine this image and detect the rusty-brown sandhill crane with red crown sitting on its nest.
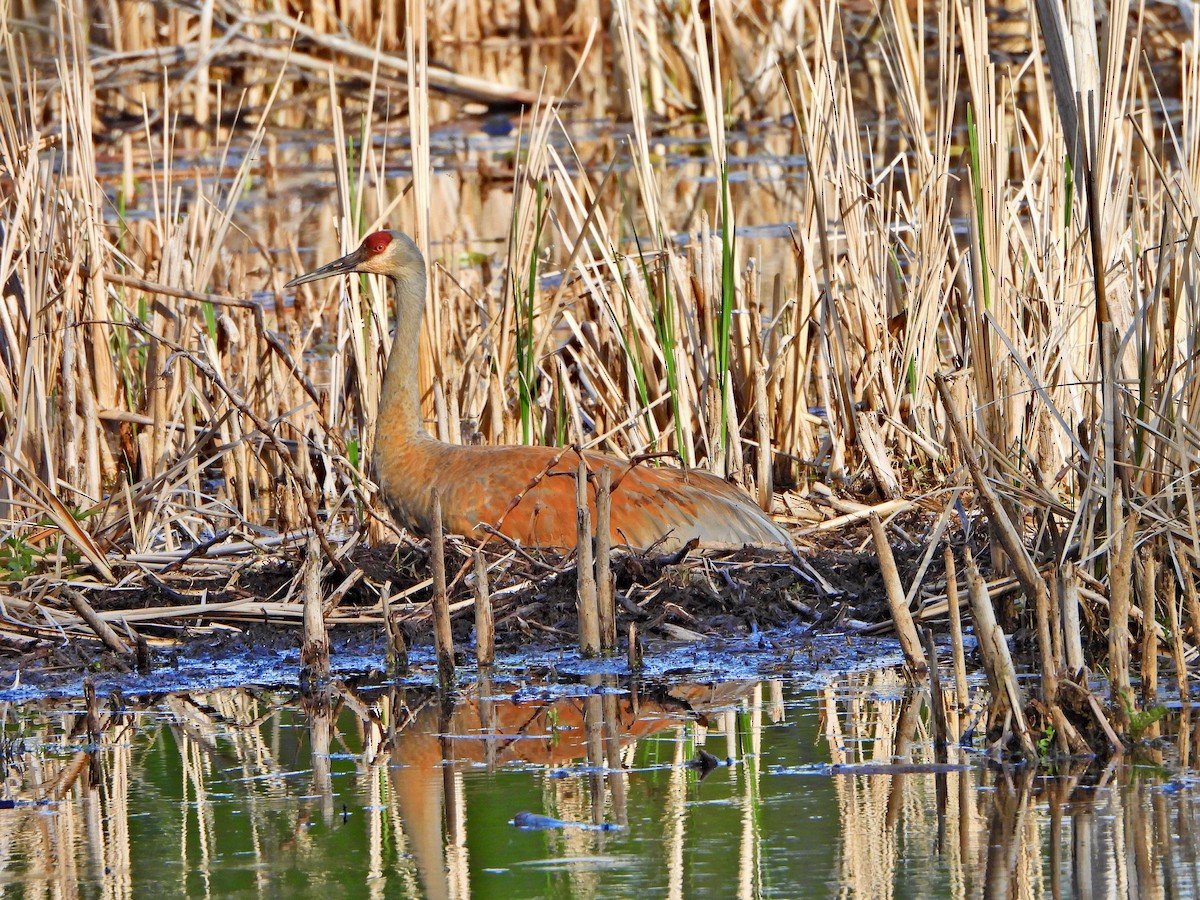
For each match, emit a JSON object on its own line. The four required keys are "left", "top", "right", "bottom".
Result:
{"left": 286, "top": 232, "right": 790, "bottom": 550}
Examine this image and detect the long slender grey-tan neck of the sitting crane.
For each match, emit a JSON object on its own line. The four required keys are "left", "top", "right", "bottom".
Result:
{"left": 376, "top": 272, "right": 430, "bottom": 448}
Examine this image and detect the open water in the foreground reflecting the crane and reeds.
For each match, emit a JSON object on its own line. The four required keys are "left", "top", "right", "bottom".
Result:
{"left": 0, "top": 668, "right": 1200, "bottom": 898}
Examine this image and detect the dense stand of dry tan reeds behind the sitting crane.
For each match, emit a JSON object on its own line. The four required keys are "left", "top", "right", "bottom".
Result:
{"left": 0, "top": 0, "right": 1200, "bottom": 752}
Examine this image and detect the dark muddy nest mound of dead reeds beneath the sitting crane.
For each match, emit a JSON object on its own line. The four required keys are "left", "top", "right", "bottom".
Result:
{"left": 0, "top": 520, "right": 916, "bottom": 681}
